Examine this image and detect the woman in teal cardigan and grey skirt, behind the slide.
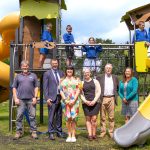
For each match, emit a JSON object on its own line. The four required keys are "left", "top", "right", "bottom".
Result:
{"left": 119, "top": 67, "right": 138, "bottom": 123}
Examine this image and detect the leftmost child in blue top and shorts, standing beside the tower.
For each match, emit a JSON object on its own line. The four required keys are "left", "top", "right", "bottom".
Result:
{"left": 39, "top": 23, "right": 53, "bottom": 68}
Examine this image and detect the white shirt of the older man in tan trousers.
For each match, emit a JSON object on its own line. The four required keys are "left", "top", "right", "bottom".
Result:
{"left": 104, "top": 74, "right": 114, "bottom": 96}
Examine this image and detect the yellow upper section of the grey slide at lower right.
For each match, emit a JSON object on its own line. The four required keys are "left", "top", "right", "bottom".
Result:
{"left": 138, "top": 95, "right": 150, "bottom": 120}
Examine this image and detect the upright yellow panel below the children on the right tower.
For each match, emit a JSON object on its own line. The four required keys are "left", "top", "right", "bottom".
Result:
{"left": 135, "top": 42, "right": 148, "bottom": 72}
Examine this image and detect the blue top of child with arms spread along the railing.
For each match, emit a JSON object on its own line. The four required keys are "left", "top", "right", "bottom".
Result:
{"left": 81, "top": 46, "right": 102, "bottom": 59}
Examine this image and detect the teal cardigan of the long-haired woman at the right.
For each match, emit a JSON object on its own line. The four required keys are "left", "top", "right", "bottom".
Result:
{"left": 119, "top": 77, "right": 138, "bottom": 101}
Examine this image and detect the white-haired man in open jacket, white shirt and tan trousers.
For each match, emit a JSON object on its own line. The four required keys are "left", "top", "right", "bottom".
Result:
{"left": 97, "top": 64, "right": 119, "bottom": 138}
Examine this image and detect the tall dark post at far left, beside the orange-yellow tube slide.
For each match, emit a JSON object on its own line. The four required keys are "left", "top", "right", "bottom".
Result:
{"left": 9, "top": 42, "right": 14, "bottom": 131}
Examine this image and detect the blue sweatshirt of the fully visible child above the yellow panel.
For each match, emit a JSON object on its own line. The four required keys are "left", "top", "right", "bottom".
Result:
{"left": 133, "top": 29, "right": 149, "bottom": 43}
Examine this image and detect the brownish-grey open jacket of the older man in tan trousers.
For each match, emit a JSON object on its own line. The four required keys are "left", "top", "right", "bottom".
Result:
{"left": 97, "top": 74, "right": 119, "bottom": 105}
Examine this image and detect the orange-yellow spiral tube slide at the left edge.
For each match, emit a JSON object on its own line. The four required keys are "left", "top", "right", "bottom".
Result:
{"left": 0, "top": 12, "right": 20, "bottom": 102}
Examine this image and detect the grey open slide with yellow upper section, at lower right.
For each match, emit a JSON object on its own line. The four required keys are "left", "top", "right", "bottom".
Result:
{"left": 113, "top": 95, "right": 150, "bottom": 147}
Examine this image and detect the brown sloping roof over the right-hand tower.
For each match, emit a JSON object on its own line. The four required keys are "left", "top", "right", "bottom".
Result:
{"left": 121, "top": 4, "right": 150, "bottom": 30}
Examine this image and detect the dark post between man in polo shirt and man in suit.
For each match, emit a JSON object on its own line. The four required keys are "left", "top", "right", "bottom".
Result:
{"left": 40, "top": 74, "right": 43, "bottom": 124}
